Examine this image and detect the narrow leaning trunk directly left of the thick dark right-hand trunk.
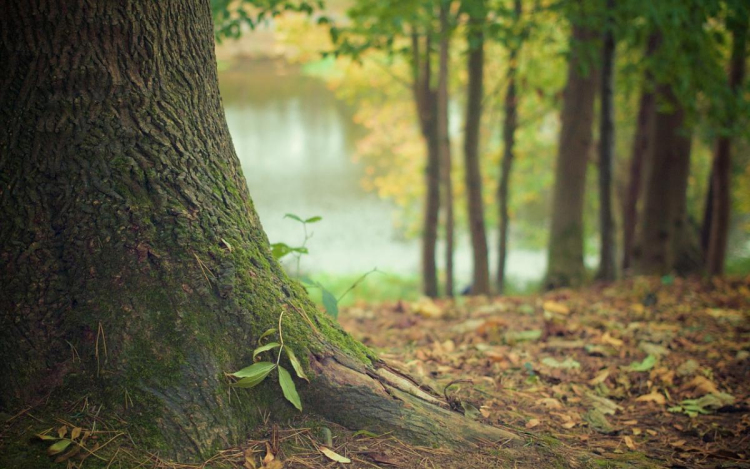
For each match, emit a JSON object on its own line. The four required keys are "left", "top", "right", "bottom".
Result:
{"left": 622, "top": 40, "right": 656, "bottom": 271}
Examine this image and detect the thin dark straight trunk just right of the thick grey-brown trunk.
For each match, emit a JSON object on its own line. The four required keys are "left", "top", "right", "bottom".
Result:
{"left": 597, "top": 0, "right": 617, "bottom": 281}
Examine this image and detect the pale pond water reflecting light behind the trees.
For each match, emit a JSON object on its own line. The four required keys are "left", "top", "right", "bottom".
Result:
{"left": 219, "top": 61, "right": 544, "bottom": 285}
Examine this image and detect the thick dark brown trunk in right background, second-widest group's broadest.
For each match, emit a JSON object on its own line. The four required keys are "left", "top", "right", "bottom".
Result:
{"left": 633, "top": 85, "right": 691, "bottom": 275}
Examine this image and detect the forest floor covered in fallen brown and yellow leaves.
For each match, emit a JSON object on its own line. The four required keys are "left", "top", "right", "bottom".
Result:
{"left": 6, "top": 277, "right": 750, "bottom": 469}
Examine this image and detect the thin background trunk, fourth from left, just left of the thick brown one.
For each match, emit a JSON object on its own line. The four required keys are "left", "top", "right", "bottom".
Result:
{"left": 497, "top": 0, "right": 522, "bottom": 295}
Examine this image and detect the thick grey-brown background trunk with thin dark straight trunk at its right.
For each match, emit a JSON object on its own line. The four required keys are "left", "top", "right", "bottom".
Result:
{"left": 545, "top": 25, "right": 596, "bottom": 289}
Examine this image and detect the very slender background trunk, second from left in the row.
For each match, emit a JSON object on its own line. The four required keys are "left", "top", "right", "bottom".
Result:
{"left": 437, "top": 0, "right": 455, "bottom": 297}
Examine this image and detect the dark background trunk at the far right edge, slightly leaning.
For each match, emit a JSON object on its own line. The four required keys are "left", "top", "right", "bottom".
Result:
{"left": 704, "top": 2, "right": 750, "bottom": 275}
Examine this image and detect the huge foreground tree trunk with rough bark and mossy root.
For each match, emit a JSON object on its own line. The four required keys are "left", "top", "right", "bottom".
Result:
{"left": 0, "top": 0, "right": 512, "bottom": 467}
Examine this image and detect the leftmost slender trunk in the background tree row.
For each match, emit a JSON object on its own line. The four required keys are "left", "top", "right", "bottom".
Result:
{"left": 412, "top": 32, "right": 440, "bottom": 298}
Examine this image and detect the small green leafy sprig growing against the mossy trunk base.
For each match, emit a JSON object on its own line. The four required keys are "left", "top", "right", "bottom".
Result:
{"left": 230, "top": 311, "right": 310, "bottom": 410}
